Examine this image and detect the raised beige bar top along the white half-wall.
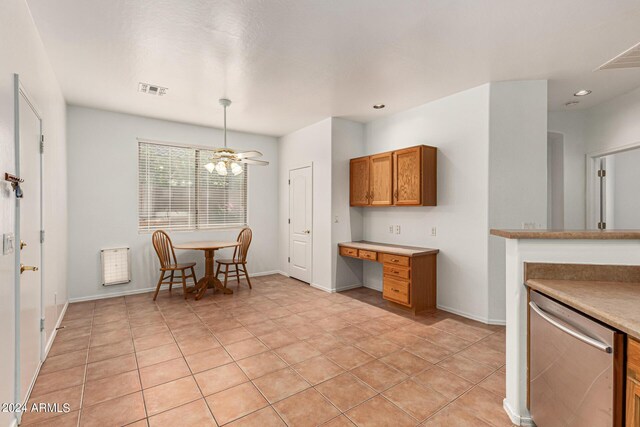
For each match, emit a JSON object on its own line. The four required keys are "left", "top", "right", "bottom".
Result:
{"left": 491, "top": 229, "right": 640, "bottom": 240}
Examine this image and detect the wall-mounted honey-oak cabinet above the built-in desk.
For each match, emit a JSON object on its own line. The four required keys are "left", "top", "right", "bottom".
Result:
{"left": 350, "top": 145, "right": 437, "bottom": 206}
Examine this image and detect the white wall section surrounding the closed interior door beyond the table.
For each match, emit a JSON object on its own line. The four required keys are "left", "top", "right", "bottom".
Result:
{"left": 278, "top": 118, "right": 333, "bottom": 291}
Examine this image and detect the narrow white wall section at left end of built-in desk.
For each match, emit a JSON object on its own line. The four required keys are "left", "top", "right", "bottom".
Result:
{"left": 331, "top": 117, "right": 365, "bottom": 291}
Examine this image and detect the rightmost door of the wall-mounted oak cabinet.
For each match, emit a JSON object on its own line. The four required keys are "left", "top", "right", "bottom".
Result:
{"left": 393, "top": 147, "right": 422, "bottom": 205}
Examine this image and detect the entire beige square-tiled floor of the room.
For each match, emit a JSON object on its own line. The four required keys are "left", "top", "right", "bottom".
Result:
{"left": 22, "top": 275, "right": 511, "bottom": 427}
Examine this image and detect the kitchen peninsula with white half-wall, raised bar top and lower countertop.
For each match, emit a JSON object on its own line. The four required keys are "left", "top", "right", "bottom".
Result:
{"left": 491, "top": 230, "right": 640, "bottom": 426}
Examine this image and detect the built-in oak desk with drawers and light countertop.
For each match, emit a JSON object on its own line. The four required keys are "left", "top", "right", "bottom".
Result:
{"left": 338, "top": 241, "right": 440, "bottom": 314}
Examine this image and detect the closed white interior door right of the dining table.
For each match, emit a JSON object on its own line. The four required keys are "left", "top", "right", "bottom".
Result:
{"left": 289, "top": 166, "right": 313, "bottom": 283}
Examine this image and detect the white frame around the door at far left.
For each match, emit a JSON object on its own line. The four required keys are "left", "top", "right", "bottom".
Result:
{"left": 14, "top": 74, "right": 46, "bottom": 422}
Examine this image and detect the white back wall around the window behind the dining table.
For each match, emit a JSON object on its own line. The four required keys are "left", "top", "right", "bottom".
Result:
{"left": 67, "top": 106, "right": 278, "bottom": 299}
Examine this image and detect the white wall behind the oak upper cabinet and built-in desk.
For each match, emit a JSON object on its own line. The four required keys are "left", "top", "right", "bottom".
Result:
{"left": 362, "top": 84, "right": 490, "bottom": 320}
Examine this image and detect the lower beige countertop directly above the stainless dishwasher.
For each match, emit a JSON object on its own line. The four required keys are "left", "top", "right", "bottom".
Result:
{"left": 527, "top": 279, "right": 640, "bottom": 339}
